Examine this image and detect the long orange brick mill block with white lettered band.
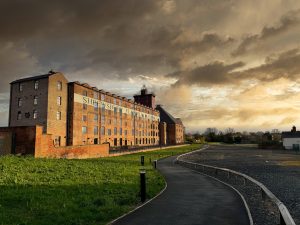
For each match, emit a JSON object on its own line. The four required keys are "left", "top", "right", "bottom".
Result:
{"left": 67, "top": 82, "right": 160, "bottom": 146}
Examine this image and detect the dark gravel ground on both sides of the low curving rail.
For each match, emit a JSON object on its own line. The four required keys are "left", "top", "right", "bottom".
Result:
{"left": 180, "top": 146, "right": 300, "bottom": 225}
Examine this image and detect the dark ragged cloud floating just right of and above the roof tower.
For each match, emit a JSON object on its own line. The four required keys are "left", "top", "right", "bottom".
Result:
{"left": 168, "top": 61, "right": 244, "bottom": 86}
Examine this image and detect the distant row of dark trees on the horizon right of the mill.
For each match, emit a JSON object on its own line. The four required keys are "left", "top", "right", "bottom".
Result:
{"left": 186, "top": 127, "right": 281, "bottom": 148}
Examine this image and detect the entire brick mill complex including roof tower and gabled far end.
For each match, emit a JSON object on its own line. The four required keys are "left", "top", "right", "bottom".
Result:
{"left": 5, "top": 71, "right": 184, "bottom": 155}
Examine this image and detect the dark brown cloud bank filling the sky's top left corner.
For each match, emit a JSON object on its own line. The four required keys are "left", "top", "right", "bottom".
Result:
{"left": 0, "top": 0, "right": 157, "bottom": 39}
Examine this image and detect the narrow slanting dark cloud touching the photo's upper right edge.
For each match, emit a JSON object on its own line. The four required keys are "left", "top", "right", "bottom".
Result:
{"left": 232, "top": 9, "right": 300, "bottom": 56}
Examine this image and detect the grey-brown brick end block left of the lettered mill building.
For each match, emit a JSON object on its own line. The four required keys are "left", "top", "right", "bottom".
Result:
{"left": 9, "top": 71, "right": 68, "bottom": 146}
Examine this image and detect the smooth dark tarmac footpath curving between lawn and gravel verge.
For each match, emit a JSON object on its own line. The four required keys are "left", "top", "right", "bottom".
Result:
{"left": 113, "top": 156, "right": 249, "bottom": 225}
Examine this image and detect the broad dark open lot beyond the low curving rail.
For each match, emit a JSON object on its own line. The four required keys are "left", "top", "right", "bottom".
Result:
{"left": 188, "top": 146, "right": 300, "bottom": 224}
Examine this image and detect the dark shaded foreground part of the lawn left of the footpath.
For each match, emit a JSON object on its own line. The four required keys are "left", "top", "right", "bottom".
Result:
{"left": 0, "top": 184, "right": 147, "bottom": 225}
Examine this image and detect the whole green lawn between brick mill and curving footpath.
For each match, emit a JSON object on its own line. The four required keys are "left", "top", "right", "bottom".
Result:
{"left": 0, "top": 145, "right": 200, "bottom": 225}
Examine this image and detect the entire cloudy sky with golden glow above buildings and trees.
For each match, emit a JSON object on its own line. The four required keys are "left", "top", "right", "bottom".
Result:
{"left": 0, "top": 0, "right": 300, "bottom": 131}
